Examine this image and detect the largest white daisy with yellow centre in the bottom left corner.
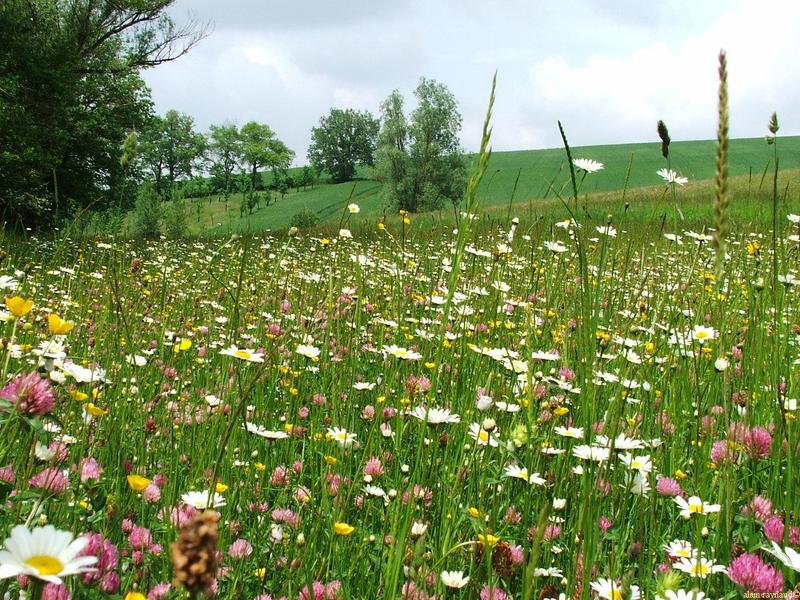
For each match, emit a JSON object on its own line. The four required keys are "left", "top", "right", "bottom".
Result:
{"left": 0, "top": 525, "right": 97, "bottom": 585}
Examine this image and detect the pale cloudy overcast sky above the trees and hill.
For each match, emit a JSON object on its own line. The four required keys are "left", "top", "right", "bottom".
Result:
{"left": 144, "top": 0, "right": 800, "bottom": 164}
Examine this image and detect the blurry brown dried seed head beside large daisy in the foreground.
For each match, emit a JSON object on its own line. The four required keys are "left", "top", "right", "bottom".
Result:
{"left": 170, "top": 511, "right": 219, "bottom": 596}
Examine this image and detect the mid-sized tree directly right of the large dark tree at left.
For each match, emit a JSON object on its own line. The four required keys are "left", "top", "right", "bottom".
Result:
{"left": 140, "top": 110, "right": 207, "bottom": 194}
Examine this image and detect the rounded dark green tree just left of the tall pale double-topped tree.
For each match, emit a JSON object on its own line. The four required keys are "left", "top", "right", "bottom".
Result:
{"left": 308, "top": 108, "right": 380, "bottom": 182}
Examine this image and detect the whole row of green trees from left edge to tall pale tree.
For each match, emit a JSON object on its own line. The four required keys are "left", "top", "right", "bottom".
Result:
{"left": 0, "top": 0, "right": 466, "bottom": 228}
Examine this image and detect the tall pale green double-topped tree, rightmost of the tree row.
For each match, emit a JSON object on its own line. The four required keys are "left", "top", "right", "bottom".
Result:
{"left": 377, "top": 77, "right": 466, "bottom": 212}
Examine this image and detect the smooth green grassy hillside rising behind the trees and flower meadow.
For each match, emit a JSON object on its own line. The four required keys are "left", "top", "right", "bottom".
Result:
{"left": 181, "top": 136, "right": 800, "bottom": 235}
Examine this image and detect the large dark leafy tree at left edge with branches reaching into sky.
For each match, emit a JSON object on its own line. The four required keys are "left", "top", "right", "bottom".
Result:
{"left": 0, "top": 0, "right": 205, "bottom": 226}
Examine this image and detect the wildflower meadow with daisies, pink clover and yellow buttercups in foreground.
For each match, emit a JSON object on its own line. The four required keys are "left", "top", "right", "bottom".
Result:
{"left": 0, "top": 123, "right": 800, "bottom": 600}
